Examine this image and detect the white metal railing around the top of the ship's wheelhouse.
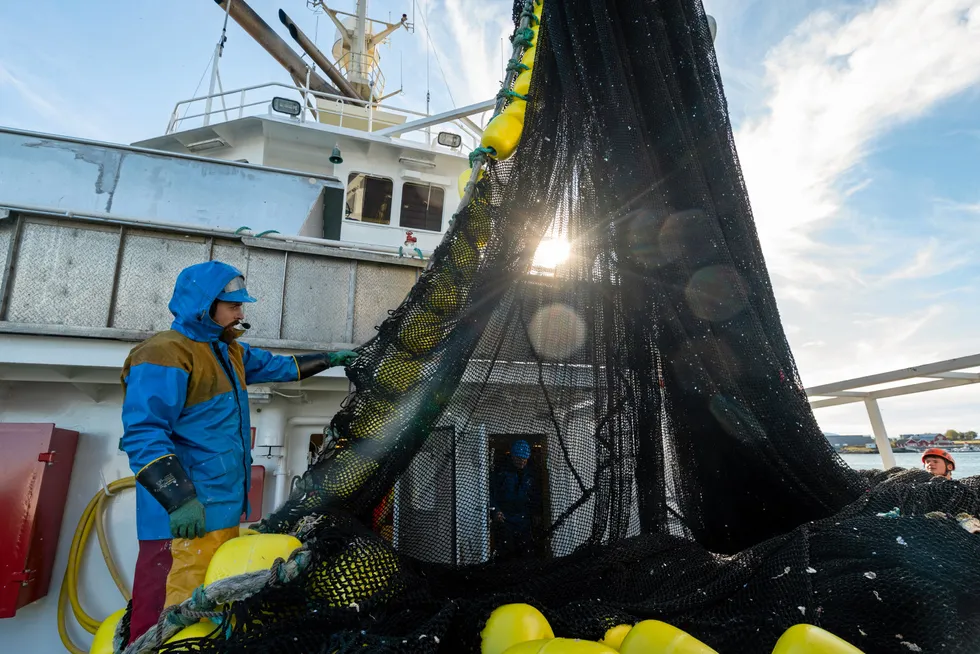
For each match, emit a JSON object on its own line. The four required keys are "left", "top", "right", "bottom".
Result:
{"left": 165, "top": 82, "right": 488, "bottom": 152}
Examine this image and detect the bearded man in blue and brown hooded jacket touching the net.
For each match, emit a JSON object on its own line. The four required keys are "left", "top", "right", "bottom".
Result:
{"left": 121, "top": 261, "right": 357, "bottom": 641}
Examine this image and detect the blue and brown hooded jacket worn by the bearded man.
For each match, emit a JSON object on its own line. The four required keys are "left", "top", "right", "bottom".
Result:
{"left": 122, "top": 261, "right": 299, "bottom": 540}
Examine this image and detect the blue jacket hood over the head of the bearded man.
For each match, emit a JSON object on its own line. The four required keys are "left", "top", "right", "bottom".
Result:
{"left": 168, "top": 261, "right": 242, "bottom": 342}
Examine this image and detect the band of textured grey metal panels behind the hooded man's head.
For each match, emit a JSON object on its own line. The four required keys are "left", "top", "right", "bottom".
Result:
{"left": 0, "top": 212, "right": 428, "bottom": 349}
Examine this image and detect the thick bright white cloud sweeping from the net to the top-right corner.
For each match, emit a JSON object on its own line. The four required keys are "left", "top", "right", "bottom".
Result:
{"left": 735, "top": 0, "right": 980, "bottom": 294}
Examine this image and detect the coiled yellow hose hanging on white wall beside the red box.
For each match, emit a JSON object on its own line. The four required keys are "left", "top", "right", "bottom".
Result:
{"left": 58, "top": 477, "right": 136, "bottom": 654}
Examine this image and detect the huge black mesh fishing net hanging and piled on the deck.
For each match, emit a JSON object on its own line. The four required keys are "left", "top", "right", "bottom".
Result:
{"left": 168, "top": 0, "right": 980, "bottom": 653}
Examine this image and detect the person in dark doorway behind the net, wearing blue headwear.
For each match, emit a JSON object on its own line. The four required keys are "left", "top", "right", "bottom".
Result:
{"left": 490, "top": 440, "right": 540, "bottom": 559}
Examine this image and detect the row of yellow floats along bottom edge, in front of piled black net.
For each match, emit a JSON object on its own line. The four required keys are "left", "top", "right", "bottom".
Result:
{"left": 480, "top": 604, "right": 861, "bottom": 654}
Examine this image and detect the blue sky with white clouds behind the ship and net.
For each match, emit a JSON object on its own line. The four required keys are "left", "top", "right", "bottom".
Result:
{"left": 0, "top": 0, "right": 980, "bottom": 435}
